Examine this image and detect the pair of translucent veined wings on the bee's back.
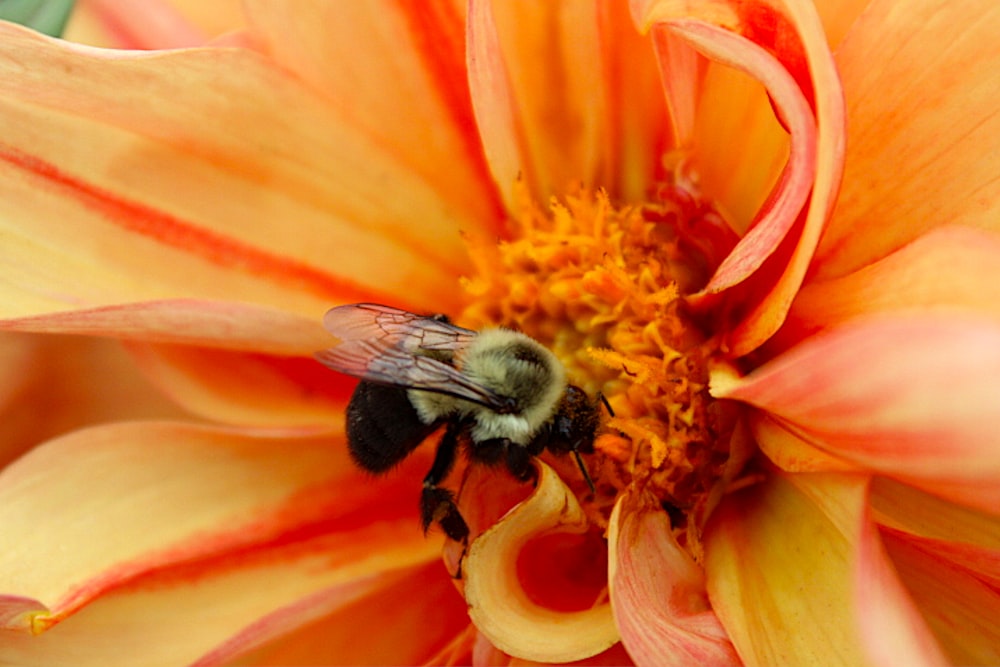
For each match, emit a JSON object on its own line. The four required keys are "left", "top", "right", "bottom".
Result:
{"left": 316, "top": 304, "right": 510, "bottom": 412}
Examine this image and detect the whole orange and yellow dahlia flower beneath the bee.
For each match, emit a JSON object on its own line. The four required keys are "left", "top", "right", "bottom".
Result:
{"left": 0, "top": 0, "right": 1000, "bottom": 665}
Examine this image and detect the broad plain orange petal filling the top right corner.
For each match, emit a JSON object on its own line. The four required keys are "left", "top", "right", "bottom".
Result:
{"left": 816, "top": 0, "right": 1000, "bottom": 279}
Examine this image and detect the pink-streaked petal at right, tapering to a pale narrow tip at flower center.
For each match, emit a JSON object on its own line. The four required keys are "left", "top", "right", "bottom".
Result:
{"left": 712, "top": 314, "right": 1000, "bottom": 511}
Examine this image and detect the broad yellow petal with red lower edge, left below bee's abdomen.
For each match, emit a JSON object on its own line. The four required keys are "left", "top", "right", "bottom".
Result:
{"left": 0, "top": 422, "right": 434, "bottom": 632}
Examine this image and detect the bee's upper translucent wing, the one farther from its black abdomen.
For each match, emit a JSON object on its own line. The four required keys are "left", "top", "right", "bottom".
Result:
{"left": 323, "top": 303, "right": 476, "bottom": 354}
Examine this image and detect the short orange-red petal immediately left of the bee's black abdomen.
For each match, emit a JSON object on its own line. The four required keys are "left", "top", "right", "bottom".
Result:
{"left": 129, "top": 344, "right": 356, "bottom": 431}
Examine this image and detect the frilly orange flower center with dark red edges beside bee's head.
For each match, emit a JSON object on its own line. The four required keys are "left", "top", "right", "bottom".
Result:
{"left": 459, "top": 177, "right": 735, "bottom": 552}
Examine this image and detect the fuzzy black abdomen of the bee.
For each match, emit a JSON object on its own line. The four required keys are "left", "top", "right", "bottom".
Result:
{"left": 347, "top": 382, "right": 439, "bottom": 473}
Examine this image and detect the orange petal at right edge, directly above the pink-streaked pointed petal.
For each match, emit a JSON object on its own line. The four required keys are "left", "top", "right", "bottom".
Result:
{"left": 788, "top": 226, "right": 1000, "bottom": 344}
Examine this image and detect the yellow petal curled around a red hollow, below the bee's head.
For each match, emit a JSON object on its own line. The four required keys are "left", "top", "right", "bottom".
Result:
{"left": 463, "top": 462, "right": 619, "bottom": 662}
